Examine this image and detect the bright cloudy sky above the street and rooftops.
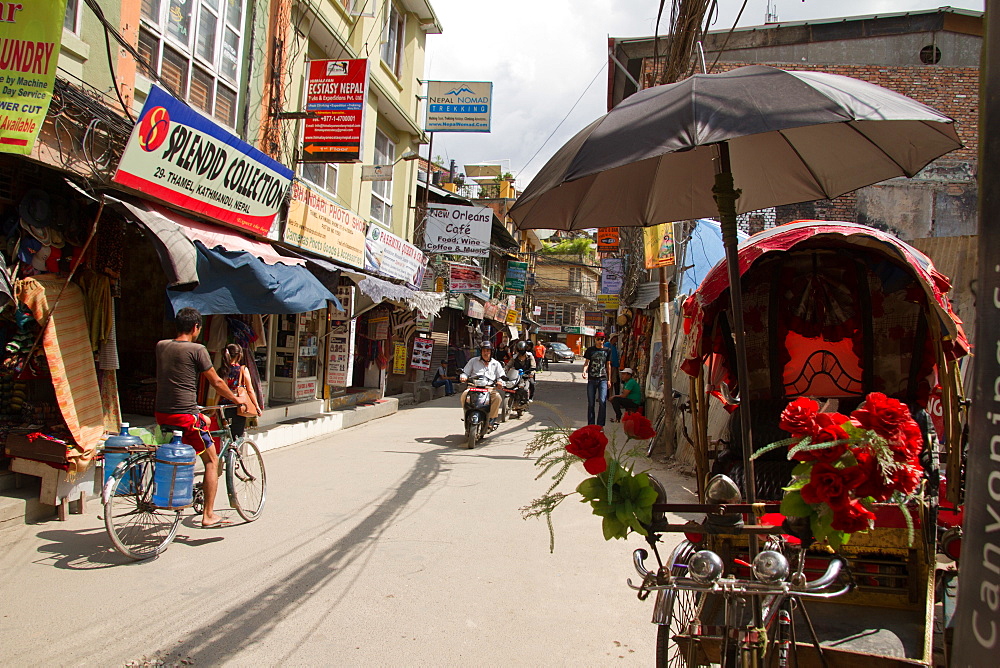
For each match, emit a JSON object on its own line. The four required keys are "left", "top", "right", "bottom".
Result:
{"left": 422, "top": 0, "right": 983, "bottom": 190}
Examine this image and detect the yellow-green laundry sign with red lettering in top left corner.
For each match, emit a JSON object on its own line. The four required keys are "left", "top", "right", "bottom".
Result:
{"left": 0, "top": 0, "right": 66, "bottom": 155}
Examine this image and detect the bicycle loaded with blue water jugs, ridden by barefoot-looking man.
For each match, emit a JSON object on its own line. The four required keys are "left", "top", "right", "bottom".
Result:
{"left": 101, "top": 404, "right": 267, "bottom": 560}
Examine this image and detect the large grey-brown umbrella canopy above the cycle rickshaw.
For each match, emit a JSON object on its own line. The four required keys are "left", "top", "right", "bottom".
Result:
{"left": 510, "top": 65, "right": 961, "bottom": 230}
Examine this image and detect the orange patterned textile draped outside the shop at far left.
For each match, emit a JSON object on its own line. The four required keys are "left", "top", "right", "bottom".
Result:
{"left": 16, "top": 274, "right": 104, "bottom": 474}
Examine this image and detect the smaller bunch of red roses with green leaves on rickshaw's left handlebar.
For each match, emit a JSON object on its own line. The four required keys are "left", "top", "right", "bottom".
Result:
{"left": 521, "top": 413, "right": 658, "bottom": 551}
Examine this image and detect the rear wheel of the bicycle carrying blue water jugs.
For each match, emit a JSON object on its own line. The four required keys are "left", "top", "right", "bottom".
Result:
{"left": 104, "top": 456, "right": 181, "bottom": 560}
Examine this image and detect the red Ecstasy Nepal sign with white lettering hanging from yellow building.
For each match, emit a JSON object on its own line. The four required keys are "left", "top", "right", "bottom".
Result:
{"left": 302, "top": 59, "right": 372, "bottom": 164}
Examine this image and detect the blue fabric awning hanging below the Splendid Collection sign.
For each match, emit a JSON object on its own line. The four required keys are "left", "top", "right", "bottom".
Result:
{"left": 167, "top": 241, "right": 343, "bottom": 315}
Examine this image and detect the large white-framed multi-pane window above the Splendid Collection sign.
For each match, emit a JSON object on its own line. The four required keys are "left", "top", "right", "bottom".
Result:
{"left": 137, "top": 0, "right": 246, "bottom": 127}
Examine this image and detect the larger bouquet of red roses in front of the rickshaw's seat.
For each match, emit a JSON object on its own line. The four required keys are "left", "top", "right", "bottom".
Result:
{"left": 753, "top": 392, "right": 924, "bottom": 549}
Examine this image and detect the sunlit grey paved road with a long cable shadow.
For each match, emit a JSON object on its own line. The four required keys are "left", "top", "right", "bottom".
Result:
{"left": 0, "top": 364, "right": 689, "bottom": 666}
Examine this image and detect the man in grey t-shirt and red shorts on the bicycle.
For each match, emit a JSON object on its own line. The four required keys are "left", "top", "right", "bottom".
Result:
{"left": 155, "top": 307, "right": 249, "bottom": 529}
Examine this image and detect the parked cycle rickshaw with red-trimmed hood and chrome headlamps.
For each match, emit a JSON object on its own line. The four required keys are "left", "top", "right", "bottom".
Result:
{"left": 634, "top": 221, "right": 969, "bottom": 668}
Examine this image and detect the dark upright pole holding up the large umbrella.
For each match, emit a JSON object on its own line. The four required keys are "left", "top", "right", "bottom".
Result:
{"left": 712, "top": 142, "right": 757, "bottom": 544}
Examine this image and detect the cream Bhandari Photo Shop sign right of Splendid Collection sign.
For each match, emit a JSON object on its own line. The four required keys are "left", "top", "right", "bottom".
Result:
{"left": 283, "top": 180, "right": 365, "bottom": 267}
